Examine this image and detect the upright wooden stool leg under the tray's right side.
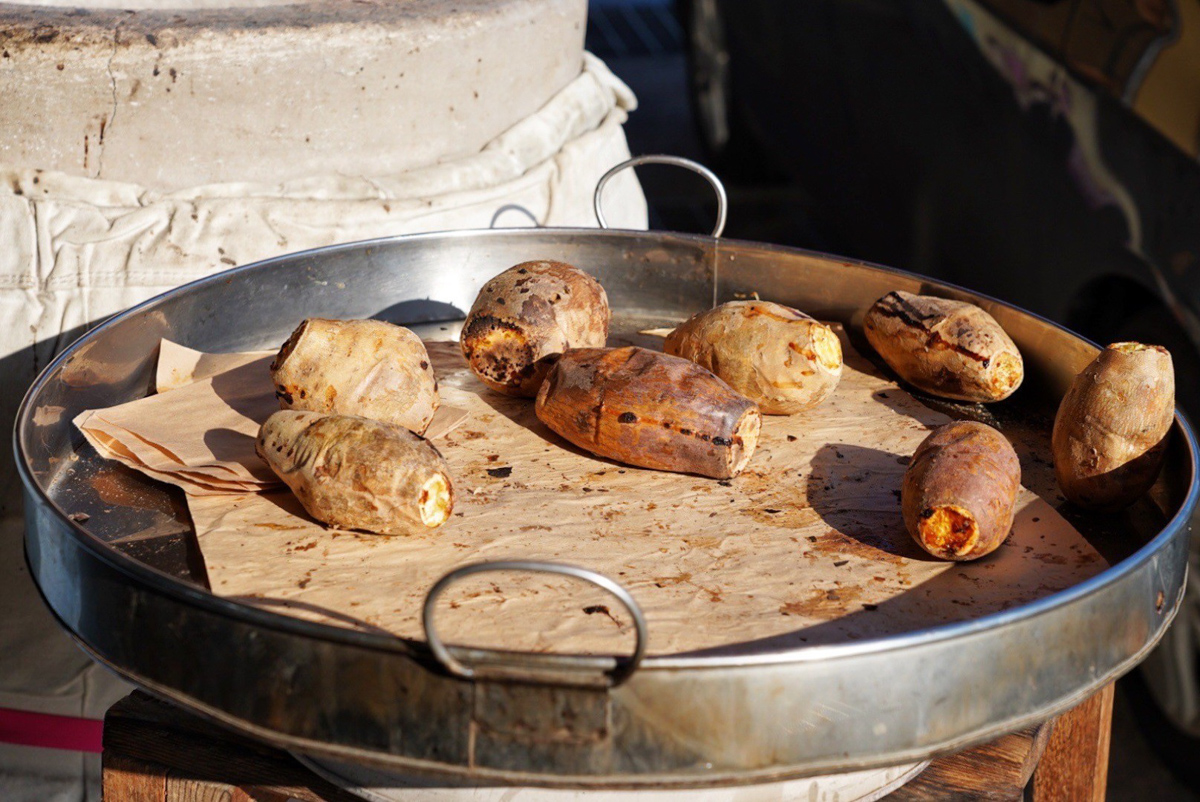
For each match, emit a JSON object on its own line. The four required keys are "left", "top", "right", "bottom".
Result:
{"left": 1028, "top": 683, "right": 1114, "bottom": 802}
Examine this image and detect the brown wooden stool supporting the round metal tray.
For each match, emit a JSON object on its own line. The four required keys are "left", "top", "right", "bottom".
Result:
{"left": 103, "top": 684, "right": 1112, "bottom": 802}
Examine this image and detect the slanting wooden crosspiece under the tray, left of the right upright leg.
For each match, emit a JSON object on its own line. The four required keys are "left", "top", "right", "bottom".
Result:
{"left": 886, "top": 723, "right": 1052, "bottom": 802}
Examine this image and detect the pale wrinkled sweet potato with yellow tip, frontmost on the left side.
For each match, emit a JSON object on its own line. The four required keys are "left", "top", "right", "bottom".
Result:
{"left": 254, "top": 409, "right": 454, "bottom": 534}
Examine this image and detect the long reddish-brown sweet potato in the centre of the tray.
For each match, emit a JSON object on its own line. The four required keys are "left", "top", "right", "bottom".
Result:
{"left": 535, "top": 347, "right": 762, "bottom": 479}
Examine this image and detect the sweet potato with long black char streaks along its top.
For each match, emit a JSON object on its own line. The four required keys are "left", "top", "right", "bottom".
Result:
{"left": 863, "top": 292, "right": 1025, "bottom": 402}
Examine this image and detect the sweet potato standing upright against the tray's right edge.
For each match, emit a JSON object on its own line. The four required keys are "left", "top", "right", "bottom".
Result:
{"left": 1051, "top": 342, "right": 1175, "bottom": 509}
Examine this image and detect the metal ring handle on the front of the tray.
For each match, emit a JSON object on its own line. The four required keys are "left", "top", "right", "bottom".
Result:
{"left": 421, "top": 559, "right": 649, "bottom": 686}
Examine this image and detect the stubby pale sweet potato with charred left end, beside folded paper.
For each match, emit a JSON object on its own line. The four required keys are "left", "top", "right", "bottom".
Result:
{"left": 271, "top": 318, "right": 438, "bottom": 433}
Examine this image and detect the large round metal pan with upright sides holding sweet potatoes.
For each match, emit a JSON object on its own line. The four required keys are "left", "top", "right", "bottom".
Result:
{"left": 16, "top": 222, "right": 1196, "bottom": 788}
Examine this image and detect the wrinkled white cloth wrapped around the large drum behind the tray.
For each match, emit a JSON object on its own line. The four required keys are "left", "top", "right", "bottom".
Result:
{"left": 0, "top": 54, "right": 647, "bottom": 802}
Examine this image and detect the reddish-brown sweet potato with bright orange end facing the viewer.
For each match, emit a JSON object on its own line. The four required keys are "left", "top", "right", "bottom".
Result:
{"left": 900, "top": 420, "right": 1021, "bottom": 559}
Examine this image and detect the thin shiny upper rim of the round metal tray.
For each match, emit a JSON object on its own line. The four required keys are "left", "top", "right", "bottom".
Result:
{"left": 13, "top": 227, "right": 1200, "bottom": 675}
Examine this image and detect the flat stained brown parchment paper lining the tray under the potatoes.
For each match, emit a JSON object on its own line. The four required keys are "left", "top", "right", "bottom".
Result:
{"left": 177, "top": 341, "right": 1105, "bottom": 654}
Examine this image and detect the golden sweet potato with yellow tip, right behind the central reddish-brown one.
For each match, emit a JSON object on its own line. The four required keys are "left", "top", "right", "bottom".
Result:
{"left": 662, "top": 300, "right": 842, "bottom": 415}
